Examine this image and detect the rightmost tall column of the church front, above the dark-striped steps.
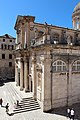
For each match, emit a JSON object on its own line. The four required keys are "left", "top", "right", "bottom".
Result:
{"left": 32, "top": 57, "right": 37, "bottom": 100}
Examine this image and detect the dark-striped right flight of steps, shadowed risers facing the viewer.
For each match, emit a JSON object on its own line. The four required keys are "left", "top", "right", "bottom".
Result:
{"left": 13, "top": 97, "right": 40, "bottom": 114}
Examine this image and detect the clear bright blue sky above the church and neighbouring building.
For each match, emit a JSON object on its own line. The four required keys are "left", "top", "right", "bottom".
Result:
{"left": 0, "top": 0, "right": 80, "bottom": 37}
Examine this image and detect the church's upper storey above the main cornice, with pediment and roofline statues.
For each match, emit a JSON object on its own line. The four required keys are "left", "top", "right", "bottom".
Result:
{"left": 15, "top": 16, "right": 80, "bottom": 49}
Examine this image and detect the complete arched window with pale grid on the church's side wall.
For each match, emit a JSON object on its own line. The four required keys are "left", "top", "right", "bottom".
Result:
{"left": 52, "top": 60, "right": 66, "bottom": 72}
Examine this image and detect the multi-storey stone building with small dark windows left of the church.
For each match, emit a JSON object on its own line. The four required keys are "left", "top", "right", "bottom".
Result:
{"left": 0, "top": 34, "right": 15, "bottom": 80}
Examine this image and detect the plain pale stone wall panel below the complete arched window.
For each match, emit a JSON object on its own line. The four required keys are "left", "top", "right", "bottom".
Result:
{"left": 52, "top": 73, "right": 67, "bottom": 108}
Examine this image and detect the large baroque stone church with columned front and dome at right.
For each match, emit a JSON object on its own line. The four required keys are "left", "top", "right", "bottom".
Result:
{"left": 14, "top": 3, "right": 80, "bottom": 111}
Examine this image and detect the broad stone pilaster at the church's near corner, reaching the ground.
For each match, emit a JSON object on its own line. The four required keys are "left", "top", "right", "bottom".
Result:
{"left": 42, "top": 54, "right": 52, "bottom": 111}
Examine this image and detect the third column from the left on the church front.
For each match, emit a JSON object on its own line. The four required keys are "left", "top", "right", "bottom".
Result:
{"left": 24, "top": 58, "right": 29, "bottom": 92}
